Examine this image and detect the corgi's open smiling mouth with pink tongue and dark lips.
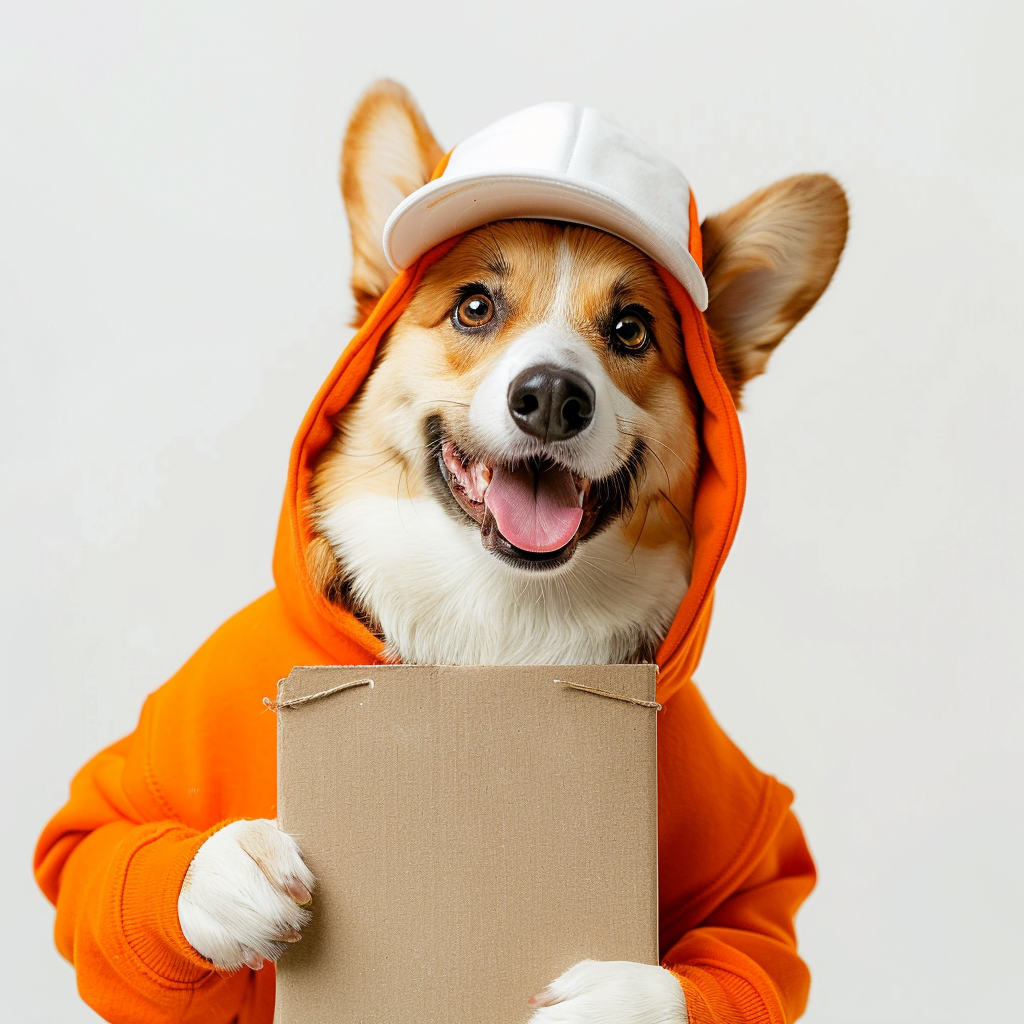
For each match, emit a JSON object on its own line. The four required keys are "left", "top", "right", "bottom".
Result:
{"left": 437, "top": 436, "right": 598, "bottom": 569}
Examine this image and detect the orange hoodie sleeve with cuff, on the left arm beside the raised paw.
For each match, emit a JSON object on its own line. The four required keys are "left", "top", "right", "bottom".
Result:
{"left": 35, "top": 698, "right": 252, "bottom": 1024}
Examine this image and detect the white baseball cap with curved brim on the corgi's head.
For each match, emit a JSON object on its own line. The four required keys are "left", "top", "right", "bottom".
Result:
{"left": 384, "top": 102, "right": 708, "bottom": 310}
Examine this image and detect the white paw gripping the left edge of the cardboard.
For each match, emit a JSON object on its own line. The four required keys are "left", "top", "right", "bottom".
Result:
{"left": 178, "top": 818, "right": 313, "bottom": 971}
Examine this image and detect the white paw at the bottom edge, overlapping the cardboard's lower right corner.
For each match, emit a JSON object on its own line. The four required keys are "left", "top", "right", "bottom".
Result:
{"left": 529, "top": 961, "right": 687, "bottom": 1024}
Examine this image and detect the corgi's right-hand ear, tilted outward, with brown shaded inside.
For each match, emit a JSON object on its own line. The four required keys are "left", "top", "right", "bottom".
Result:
{"left": 700, "top": 174, "right": 848, "bottom": 403}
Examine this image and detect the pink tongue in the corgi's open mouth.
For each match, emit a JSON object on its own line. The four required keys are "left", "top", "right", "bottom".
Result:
{"left": 483, "top": 466, "right": 583, "bottom": 552}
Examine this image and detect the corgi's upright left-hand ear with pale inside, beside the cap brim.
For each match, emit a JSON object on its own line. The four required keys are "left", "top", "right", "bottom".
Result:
{"left": 341, "top": 79, "right": 442, "bottom": 326}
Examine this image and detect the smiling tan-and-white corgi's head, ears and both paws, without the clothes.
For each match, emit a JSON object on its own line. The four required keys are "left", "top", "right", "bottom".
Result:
{"left": 178, "top": 82, "right": 847, "bottom": 1024}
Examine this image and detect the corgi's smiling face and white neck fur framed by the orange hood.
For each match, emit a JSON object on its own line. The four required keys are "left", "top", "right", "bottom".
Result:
{"left": 313, "top": 221, "right": 697, "bottom": 660}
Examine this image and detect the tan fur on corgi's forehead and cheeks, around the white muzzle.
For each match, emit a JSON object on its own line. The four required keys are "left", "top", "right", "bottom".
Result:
{"left": 312, "top": 221, "right": 697, "bottom": 581}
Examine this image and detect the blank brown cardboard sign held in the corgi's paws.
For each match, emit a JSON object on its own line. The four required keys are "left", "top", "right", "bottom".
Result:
{"left": 274, "top": 665, "right": 658, "bottom": 1024}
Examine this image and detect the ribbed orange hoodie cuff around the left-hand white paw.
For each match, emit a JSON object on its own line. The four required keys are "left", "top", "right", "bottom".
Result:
{"left": 121, "top": 822, "right": 227, "bottom": 985}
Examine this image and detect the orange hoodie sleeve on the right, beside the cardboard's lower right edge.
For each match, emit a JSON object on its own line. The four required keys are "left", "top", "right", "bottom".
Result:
{"left": 663, "top": 811, "right": 814, "bottom": 1024}
